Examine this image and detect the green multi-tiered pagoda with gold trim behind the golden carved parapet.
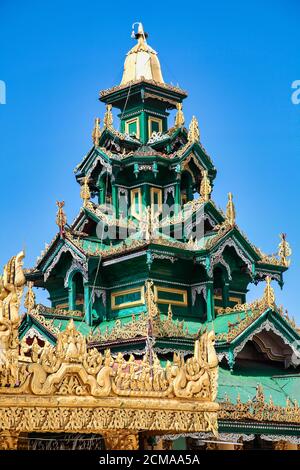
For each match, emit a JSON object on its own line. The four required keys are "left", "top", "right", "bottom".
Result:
{"left": 19, "top": 23, "right": 300, "bottom": 448}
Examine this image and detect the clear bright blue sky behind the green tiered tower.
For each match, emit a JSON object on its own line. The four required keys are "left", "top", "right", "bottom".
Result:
{"left": 0, "top": 0, "right": 300, "bottom": 320}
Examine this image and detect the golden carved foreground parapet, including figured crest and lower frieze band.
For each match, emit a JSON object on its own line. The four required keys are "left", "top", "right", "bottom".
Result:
{"left": 0, "top": 320, "right": 218, "bottom": 433}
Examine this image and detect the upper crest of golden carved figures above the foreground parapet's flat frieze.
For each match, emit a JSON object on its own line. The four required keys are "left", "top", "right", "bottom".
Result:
{"left": 1, "top": 320, "right": 218, "bottom": 401}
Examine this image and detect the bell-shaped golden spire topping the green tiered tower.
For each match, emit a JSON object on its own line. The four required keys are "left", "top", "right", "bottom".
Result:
{"left": 121, "top": 23, "right": 164, "bottom": 85}
